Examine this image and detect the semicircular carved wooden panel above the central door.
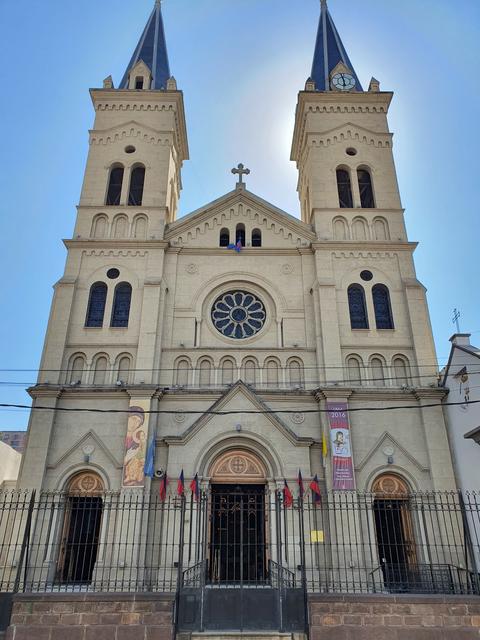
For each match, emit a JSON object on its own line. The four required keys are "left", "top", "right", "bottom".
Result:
{"left": 208, "top": 449, "right": 267, "bottom": 484}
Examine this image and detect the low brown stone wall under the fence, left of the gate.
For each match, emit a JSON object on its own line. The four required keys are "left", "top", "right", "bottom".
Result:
{"left": 6, "top": 593, "right": 173, "bottom": 640}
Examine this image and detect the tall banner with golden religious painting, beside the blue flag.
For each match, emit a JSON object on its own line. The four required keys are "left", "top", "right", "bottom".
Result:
{"left": 123, "top": 399, "right": 149, "bottom": 487}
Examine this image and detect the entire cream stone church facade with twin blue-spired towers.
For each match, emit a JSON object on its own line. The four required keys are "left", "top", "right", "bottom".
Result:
{"left": 8, "top": 0, "right": 468, "bottom": 616}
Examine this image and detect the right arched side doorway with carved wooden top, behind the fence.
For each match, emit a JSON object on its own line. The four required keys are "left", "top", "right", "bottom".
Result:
{"left": 372, "top": 474, "right": 417, "bottom": 592}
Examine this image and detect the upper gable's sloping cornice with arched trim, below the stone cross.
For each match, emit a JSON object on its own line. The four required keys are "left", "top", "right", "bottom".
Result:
{"left": 165, "top": 189, "right": 316, "bottom": 244}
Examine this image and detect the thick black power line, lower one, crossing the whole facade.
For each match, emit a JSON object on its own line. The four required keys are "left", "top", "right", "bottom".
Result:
{"left": 0, "top": 400, "right": 480, "bottom": 416}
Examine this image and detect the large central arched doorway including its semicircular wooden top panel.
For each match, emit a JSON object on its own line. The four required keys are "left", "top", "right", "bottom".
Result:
{"left": 209, "top": 449, "right": 268, "bottom": 585}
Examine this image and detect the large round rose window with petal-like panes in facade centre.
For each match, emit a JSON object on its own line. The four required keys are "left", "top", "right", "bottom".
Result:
{"left": 212, "top": 291, "right": 267, "bottom": 340}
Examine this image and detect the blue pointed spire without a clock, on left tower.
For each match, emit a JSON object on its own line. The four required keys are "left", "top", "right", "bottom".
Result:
{"left": 120, "top": 0, "right": 170, "bottom": 89}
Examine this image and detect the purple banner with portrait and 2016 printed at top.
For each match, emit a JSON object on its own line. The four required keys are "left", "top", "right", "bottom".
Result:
{"left": 327, "top": 402, "right": 355, "bottom": 491}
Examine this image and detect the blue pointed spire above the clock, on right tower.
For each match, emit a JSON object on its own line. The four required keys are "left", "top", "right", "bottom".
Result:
{"left": 311, "top": 0, "right": 363, "bottom": 91}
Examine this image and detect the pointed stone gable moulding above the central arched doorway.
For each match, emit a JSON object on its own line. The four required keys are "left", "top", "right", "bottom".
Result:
{"left": 164, "top": 380, "right": 314, "bottom": 447}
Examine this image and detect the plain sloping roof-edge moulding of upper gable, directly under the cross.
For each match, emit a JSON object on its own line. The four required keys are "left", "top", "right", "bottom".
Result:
{"left": 165, "top": 188, "right": 317, "bottom": 241}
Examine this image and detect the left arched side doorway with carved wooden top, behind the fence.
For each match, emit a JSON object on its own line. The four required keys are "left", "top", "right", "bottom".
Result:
{"left": 58, "top": 471, "right": 105, "bottom": 584}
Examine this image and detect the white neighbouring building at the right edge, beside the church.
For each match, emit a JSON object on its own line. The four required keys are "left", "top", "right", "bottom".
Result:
{"left": 441, "top": 333, "right": 480, "bottom": 492}
